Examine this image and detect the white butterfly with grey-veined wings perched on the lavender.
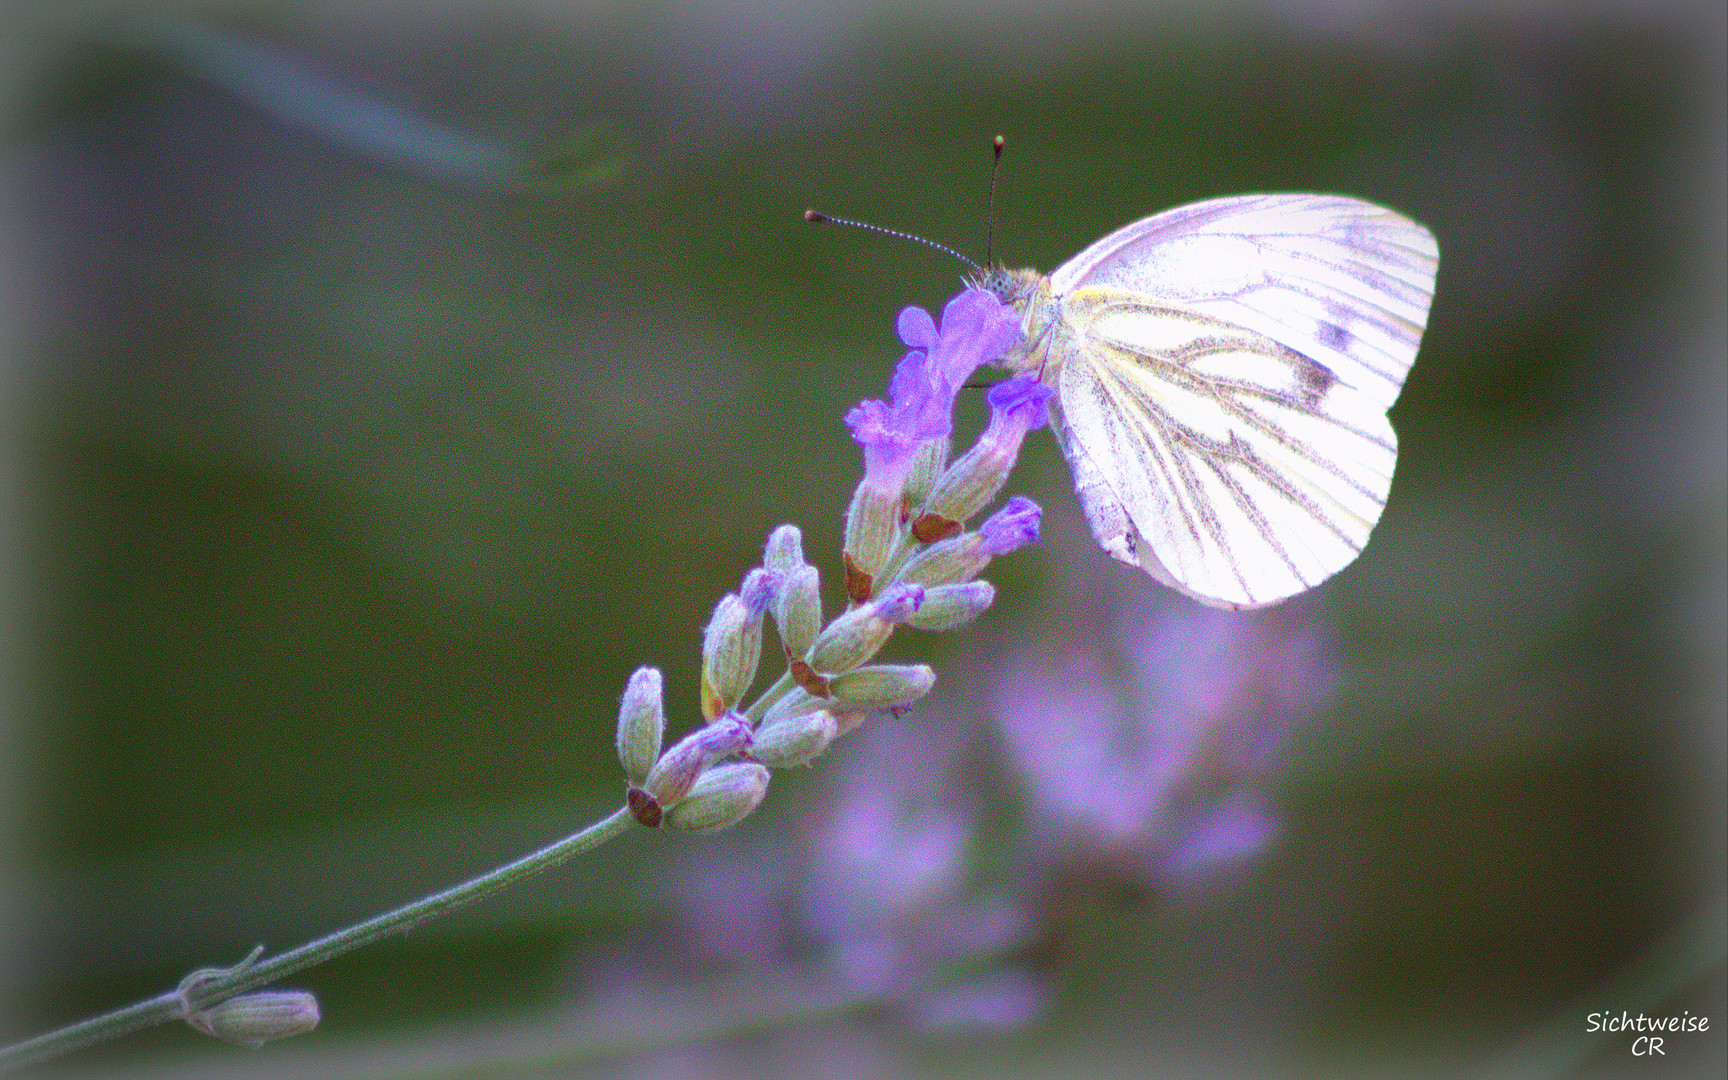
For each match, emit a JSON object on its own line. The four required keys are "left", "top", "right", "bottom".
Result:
{"left": 976, "top": 195, "right": 1439, "bottom": 608}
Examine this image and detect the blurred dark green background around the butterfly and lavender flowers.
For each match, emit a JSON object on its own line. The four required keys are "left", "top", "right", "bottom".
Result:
{"left": 0, "top": 0, "right": 1728, "bottom": 1077}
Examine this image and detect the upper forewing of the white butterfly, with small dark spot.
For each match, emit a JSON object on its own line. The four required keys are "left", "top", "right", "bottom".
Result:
{"left": 1051, "top": 195, "right": 1439, "bottom": 410}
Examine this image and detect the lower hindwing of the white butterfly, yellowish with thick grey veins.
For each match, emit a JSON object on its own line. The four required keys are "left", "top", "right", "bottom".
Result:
{"left": 1054, "top": 289, "right": 1396, "bottom": 608}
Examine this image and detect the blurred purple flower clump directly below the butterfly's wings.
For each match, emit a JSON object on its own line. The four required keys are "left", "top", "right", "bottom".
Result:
{"left": 992, "top": 584, "right": 1336, "bottom": 892}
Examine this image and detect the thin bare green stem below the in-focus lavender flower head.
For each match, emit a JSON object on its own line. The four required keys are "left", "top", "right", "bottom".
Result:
{"left": 0, "top": 807, "right": 634, "bottom": 1073}
